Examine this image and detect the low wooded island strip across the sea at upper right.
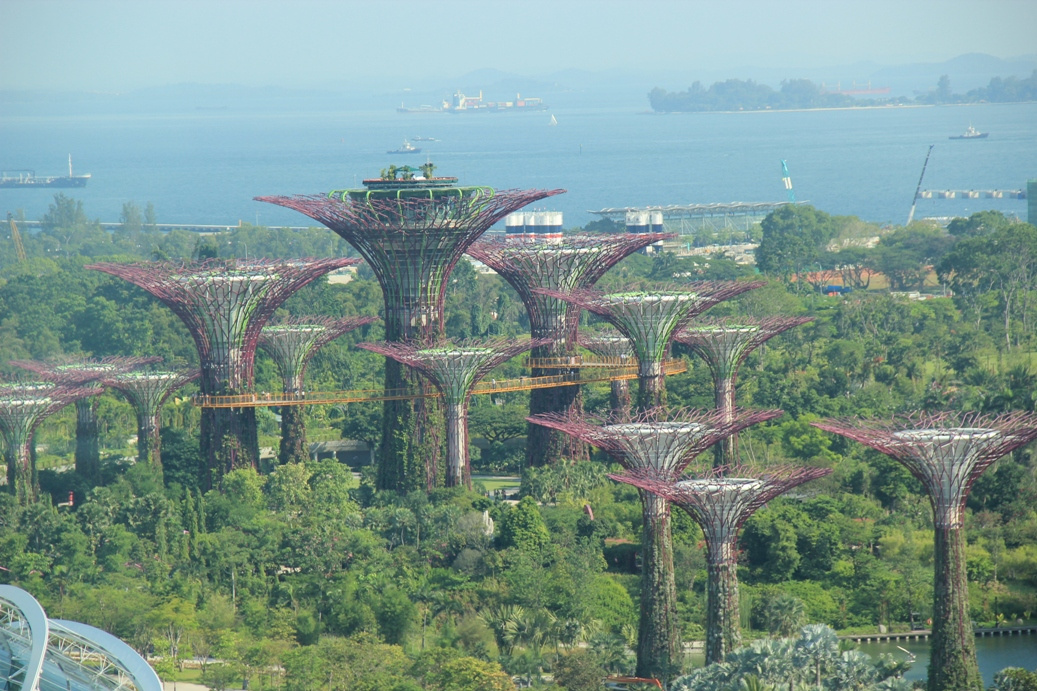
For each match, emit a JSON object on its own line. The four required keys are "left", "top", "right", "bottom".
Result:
{"left": 648, "top": 70, "right": 1037, "bottom": 113}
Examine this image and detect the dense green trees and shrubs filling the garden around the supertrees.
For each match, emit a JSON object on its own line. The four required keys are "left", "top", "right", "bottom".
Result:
{"left": 0, "top": 195, "right": 1037, "bottom": 691}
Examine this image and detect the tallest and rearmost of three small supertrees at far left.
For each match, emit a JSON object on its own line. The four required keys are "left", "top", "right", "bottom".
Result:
{"left": 10, "top": 356, "right": 162, "bottom": 485}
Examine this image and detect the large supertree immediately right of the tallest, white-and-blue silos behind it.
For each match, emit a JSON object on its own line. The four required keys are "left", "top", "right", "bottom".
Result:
{"left": 468, "top": 233, "right": 675, "bottom": 466}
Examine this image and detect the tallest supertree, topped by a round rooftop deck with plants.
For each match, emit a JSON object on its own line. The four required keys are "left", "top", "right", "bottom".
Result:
{"left": 256, "top": 177, "right": 563, "bottom": 491}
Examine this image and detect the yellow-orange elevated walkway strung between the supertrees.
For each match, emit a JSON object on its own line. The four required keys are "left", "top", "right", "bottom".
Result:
{"left": 191, "top": 358, "right": 688, "bottom": 408}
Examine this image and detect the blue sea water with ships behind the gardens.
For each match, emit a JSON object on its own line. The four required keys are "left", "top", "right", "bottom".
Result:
{"left": 0, "top": 94, "right": 1037, "bottom": 227}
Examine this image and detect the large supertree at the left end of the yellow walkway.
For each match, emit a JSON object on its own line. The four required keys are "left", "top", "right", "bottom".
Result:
{"left": 86, "top": 258, "right": 359, "bottom": 485}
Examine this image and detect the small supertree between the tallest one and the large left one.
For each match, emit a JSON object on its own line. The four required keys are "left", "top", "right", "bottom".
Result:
{"left": 259, "top": 316, "right": 379, "bottom": 464}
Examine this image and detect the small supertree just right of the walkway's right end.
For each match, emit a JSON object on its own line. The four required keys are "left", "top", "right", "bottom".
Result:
{"left": 673, "top": 316, "right": 814, "bottom": 466}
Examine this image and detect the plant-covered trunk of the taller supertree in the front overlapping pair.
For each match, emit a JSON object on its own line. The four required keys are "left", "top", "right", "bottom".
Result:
{"left": 637, "top": 491, "right": 683, "bottom": 680}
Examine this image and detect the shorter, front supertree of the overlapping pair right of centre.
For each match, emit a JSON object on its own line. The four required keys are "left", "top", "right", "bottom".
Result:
{"left": 610, "top": 466, "right": 832, "bottom": 664}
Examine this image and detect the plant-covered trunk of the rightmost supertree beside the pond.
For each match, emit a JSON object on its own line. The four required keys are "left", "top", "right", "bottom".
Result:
{"left": 926, "top": 525, "right": 983, "bottom": 691}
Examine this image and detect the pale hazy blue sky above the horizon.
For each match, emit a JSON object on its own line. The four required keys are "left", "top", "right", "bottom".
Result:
{"left": 0, "top": 0, "right": 1037, "bottom": 90}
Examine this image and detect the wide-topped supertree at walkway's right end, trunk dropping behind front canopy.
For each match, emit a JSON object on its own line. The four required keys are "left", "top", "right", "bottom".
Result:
{"left": 539, "top": 281, "right": 765, "bottom": 410}
